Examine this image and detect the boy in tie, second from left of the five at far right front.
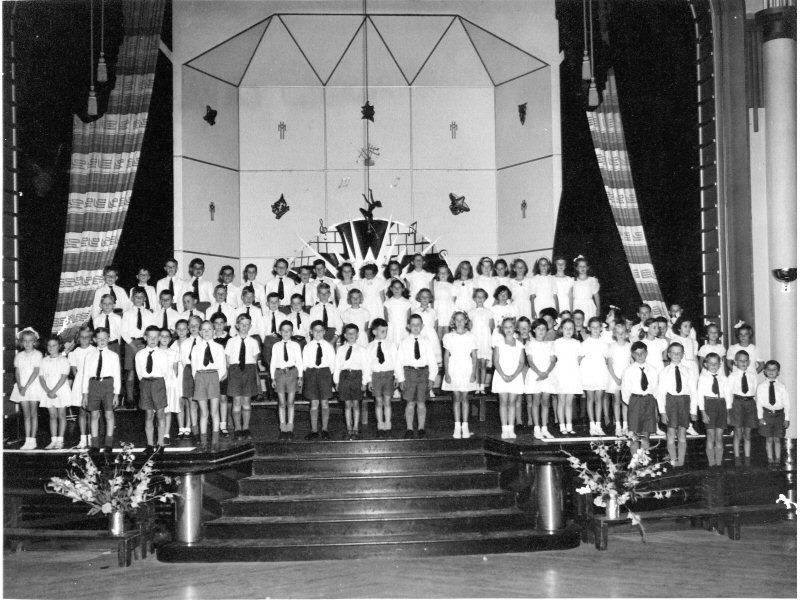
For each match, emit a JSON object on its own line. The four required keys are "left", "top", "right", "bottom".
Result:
{"left": 656, "top": 342, "right": 697, "bottom": 468}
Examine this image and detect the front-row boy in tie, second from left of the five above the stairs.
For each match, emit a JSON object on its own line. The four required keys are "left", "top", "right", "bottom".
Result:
{"left": 303, "top": 321, "right": 336, "bottom": 441}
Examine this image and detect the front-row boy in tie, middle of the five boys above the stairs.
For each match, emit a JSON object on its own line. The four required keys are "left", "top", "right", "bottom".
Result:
{"left": 333, "top": 326, "right": 370, "bottom": 440}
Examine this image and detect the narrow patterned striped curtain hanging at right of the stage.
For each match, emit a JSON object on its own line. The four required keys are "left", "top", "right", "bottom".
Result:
{"left": 586, "top": 69, "right": 667, "bottom": 316}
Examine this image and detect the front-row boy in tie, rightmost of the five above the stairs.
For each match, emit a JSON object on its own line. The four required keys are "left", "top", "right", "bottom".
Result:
{"left": 395, "top": 313, "right": 439, "bottom": 439}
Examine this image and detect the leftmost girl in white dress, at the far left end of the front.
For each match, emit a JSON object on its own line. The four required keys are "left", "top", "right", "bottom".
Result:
{"left": 11, "top": 327, "right": 44, "bottom": 450}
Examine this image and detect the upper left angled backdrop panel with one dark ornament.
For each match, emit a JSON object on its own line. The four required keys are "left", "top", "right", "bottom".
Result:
{"left": 182, "top": 66, "right": 239, "bottom": 170}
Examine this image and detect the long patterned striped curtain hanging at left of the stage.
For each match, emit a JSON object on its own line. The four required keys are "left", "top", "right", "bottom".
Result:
{"left": 53, "top": 0, "right": 164, "bottom": 335}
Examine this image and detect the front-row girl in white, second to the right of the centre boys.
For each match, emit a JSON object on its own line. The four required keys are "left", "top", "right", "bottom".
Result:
{"left": 492, "top": 319, "right": 525, "bottom": 439}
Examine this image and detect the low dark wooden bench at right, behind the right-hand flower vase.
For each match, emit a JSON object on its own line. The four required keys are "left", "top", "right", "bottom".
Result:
{"left": 583, "top": 504, "right": 787, "bottom": 550}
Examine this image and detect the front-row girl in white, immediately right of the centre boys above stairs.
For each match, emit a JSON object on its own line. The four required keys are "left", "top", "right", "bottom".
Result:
{"left": 442, "top": 310, "right": 478, "bottom": 439}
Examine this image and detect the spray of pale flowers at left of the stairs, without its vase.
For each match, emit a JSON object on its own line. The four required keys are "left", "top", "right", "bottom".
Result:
{"left": 45, "top": 444, "right": 177, "bottom": 515}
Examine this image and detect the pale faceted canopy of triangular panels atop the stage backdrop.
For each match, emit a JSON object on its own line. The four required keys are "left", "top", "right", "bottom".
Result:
{"left": 186, "top": 14, "right": 547, "bottom": 87}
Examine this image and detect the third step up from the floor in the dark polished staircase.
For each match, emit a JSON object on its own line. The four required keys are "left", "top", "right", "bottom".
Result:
{"left": 222, "top": 488, "right": 516, "bottom": 517}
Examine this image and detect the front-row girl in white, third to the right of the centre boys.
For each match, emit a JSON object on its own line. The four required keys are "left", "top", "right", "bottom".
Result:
{"left": 525, "top": 319, "right": 556, "bottom": 440}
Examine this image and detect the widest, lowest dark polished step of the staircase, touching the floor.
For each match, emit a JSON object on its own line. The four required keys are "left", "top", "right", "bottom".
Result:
{"left": 157, "top": 527, "right": 580, "bottom": 562}
